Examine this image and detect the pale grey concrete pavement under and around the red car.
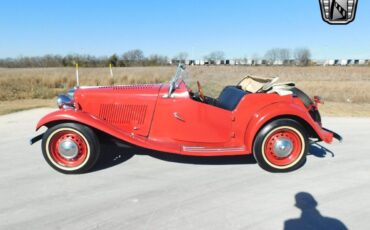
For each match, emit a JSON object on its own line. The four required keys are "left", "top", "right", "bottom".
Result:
{"left": 0, "top": 109, "right": 370, "bottom": 230}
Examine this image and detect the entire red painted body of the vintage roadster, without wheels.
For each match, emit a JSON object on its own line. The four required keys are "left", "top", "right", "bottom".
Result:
{"left": 37, "top": 82, "right": 333, "bottom": 156}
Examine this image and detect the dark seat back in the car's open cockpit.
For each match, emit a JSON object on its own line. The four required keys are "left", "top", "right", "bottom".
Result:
{"left": 217, "top": 86, "right": 247, "bottom": 111}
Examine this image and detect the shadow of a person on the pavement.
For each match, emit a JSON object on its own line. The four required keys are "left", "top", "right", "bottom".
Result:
{"left": 284, "top": 192, "right": 348, "bottom": 230}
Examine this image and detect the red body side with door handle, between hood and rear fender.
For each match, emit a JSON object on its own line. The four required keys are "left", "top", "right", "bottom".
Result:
{"left": 152, "top": 92, "right": 232, "bottom": 143}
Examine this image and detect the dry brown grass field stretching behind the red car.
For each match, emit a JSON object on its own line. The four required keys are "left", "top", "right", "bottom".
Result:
{"left": 0, "top": 66, "right": 370, "bottom": 116}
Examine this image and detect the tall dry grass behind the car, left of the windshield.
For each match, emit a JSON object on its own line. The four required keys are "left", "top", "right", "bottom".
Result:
{"left": 0, "top": 67, "right": 173, "bottom": 101}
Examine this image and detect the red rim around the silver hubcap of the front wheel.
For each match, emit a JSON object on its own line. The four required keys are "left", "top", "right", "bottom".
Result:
{"left": 49, "top": 130, "right": 88, "bottom": 168}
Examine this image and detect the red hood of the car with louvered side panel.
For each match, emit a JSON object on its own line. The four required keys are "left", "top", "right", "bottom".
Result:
{"left": 74, "top": 84, "right": 162, "bottom": 136}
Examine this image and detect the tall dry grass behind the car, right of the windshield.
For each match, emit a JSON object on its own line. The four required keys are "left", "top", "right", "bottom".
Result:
{"left": 186, "top": 67, "right": 370, "bottom": 103}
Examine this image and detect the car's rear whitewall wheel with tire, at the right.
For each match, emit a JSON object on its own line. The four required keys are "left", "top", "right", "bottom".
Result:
{"left": 253, "top": 119, "right": 309, "bottom": 172}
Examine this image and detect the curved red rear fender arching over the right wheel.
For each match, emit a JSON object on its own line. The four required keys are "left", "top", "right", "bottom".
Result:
{"left": 245, "top": 102, "right": 333, "bottom": 152}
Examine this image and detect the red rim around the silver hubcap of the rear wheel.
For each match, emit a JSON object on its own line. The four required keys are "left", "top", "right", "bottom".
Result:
{"left": 264, "top": 128, "right": 302, "bottom": 166}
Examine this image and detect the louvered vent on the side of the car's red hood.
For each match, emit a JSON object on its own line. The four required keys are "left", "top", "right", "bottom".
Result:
{"left": 99, "top": 104, "right": 147, "bottom": 125}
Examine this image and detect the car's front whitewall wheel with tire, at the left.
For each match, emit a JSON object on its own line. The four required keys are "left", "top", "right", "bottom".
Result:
{"left": 42, "top": 123, "right": 100, "bottom": 174}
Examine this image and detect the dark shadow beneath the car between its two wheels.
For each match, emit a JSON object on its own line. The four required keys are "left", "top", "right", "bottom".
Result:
{"left": 91, "top": 137, "right": 256, "bottom": 172}
